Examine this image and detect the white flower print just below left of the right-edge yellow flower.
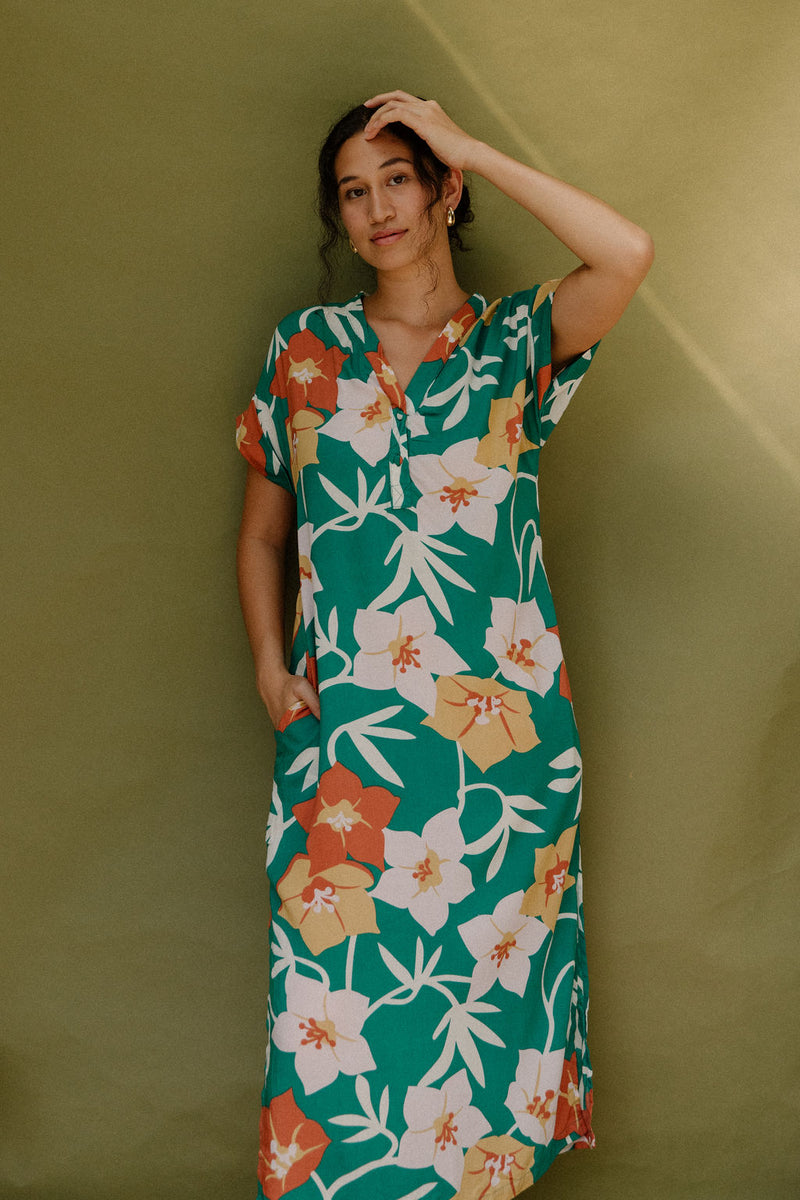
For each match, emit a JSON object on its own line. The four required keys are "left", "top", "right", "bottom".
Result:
{"left": 458, "top": 892, "right": 548, "bottom": 1001}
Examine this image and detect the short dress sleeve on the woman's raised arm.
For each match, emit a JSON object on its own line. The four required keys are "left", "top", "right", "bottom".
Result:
{"left": 527, "top": 280, "right": 600, "bottom": 445}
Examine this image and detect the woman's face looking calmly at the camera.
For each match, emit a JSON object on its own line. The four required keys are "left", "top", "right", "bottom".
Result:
{"left": 335, "top": 131, "right": 447, "bottom": 270}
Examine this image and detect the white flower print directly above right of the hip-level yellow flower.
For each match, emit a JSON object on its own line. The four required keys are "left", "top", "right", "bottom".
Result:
{"left": 486, "top": 596, "right": 561, "bottom": 696}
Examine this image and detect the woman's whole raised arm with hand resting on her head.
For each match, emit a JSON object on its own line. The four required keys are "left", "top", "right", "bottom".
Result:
{"left": 365, "top": 91, "right": 654, "bottom": 371}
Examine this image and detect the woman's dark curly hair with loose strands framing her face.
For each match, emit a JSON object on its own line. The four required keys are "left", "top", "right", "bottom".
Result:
{"left": 317, "top": 104, "right": 475, "bottom": 298}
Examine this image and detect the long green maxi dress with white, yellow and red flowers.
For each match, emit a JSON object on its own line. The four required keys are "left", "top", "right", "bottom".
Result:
{"left": 237, "top": 281, "right": 595, "bottom": 1200}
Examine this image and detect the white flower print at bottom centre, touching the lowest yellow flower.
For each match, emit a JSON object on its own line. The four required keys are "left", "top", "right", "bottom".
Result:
{"left": 397, "top": 1068, "right": 491, "bottom": 1188}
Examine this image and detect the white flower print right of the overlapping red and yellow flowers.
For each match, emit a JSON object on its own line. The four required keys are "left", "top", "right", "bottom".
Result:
{"left": 371, "top": 809, "right": 475, "bottom": 934}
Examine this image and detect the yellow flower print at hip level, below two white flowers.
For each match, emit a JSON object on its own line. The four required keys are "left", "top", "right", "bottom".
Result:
{"left": 422, "top": 676, "right": 539, "bottom": 770}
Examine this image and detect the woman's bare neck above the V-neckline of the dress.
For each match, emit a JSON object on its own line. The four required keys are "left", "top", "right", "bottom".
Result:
{"left": 363, "top": 253, "right": 468, "bottom": 329}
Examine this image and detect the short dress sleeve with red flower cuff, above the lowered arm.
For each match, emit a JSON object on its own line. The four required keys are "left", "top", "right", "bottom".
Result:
{"left": 236, "top": 329, "right": 295, "bottom": 496}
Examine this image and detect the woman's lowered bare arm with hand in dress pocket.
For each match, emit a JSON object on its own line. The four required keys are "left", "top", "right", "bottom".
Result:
{"left": 236, "top": 466, "right": 319, "bottom": 726}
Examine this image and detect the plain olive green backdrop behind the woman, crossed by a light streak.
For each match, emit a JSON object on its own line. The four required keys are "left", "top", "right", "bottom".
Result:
{"left": 0, "top": 0, "right": 800, "bottom": 1200}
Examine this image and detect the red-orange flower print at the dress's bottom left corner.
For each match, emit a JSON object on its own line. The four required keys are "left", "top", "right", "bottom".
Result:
{"left": 258, "top": 1088, "right": 331, "bottom": 1200}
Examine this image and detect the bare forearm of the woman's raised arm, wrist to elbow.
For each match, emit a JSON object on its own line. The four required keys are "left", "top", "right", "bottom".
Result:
{"left": 464, "top": 142, "right": 652, "bottom": 276}
